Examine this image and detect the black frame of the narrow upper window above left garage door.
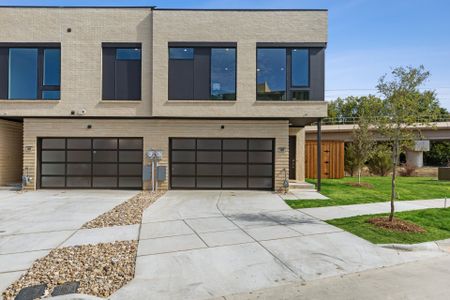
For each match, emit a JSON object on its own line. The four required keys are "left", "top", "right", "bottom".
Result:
{"left": 101, "top": 42, "right": 143, "bottom": 102}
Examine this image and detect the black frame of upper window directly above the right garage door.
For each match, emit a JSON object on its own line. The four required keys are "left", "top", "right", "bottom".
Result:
{"left": 167, "top": 42, "right": 238, "bottom": 102}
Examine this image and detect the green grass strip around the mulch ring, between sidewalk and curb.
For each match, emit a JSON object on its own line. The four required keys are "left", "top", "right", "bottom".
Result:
{"left": 327, "top": 208, "right": 450, "bottom": 244}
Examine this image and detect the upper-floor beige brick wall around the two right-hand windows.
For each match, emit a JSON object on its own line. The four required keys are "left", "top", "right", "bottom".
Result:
{"left": 153, "top": 10, "right": 327, "bottom": 118}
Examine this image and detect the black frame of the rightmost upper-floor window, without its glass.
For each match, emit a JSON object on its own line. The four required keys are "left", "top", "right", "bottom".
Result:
{"left": 255, "top": 45, "right": 311, "bottom": 101}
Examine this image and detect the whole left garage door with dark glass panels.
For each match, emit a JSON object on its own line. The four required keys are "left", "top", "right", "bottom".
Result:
{"left": 39, "top": 138, "right": 143, "bottom": 189}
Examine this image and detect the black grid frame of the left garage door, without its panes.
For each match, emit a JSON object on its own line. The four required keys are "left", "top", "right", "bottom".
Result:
{"left": 36, "top": 137, "right": 144, "bottom": 190}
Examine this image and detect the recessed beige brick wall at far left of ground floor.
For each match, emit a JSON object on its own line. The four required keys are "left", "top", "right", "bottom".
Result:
{"left": 0, "top": 120, "right": 23, "bottom": 186}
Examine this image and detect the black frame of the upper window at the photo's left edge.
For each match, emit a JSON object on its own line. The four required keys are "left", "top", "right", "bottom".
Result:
{"left": 0, "top": 43, "right": 62, "bottom": 101}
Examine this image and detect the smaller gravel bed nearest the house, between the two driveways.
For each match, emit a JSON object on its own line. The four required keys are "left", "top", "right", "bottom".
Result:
{"left": 82, "top": 191, "right": 164, "bottom": 228}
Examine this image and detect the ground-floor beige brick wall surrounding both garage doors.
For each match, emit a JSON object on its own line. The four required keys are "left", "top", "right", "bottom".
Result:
{"left": 24, "top": 118, "right": 289, "bottom": 190}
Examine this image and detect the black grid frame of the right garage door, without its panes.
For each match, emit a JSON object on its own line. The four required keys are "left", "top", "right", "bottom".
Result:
{"left": 169, "top": 137, "right": 275, "bottom": 191}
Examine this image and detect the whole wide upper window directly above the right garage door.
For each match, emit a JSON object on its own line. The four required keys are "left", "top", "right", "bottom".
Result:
{"left": 169, "top": 47, "right": 236, "bottom": 100}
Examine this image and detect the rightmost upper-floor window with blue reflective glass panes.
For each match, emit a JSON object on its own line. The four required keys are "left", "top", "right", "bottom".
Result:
{"left": 256, "top": 48, "right": 310, "bottom": 100}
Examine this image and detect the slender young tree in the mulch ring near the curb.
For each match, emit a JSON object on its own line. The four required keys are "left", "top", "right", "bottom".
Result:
{"left": 377, "top": 66, "right": 440, "bottom": 221}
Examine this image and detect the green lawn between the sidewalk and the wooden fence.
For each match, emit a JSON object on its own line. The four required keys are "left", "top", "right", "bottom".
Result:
{"left": 286, "top": 177, "right": 450, "bottom": 208}
